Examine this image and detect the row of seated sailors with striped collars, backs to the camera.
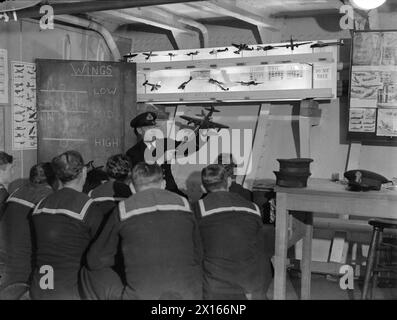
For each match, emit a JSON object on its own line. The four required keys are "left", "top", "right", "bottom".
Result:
{"left": 0, "top": 151, "right": 271, "bottom": 300}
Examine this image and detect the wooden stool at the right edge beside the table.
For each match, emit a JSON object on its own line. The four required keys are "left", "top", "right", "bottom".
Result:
{"left": 361, "top": 219, "right": 397, "bottom": 299}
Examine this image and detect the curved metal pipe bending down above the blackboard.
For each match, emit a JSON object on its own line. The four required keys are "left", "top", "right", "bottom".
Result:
{"left": 54, "top": 15, "right": 121, "bottom": 61}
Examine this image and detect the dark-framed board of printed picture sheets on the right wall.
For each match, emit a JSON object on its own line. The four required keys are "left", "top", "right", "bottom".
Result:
{"left": 348, "top": 30, "right": 397, "bottom": 145}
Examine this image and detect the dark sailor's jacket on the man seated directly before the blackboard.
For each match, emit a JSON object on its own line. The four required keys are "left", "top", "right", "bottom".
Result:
{"left": 31, "top": 188, "right": 104, "bottom": 299}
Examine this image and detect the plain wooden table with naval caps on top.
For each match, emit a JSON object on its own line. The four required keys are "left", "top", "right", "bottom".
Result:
{"left": 274, "top": 178, "right": 397, "bottom": 300}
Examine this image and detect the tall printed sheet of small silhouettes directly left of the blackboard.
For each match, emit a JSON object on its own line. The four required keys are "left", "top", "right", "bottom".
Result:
{"left": 11, "top": 61, "right": 37, "bottom": 150}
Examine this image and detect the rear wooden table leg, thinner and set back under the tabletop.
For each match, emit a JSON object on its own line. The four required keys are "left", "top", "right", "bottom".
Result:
{"left": 301, "top": 212, "right": 313, "bottom": 300}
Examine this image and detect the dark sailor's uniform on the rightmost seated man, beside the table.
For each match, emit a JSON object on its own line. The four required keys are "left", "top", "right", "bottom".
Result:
{"left": 195, "top": 191, "right": 271, "bottom": 300}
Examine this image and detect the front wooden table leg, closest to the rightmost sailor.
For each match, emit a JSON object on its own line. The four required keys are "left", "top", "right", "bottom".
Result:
{"left": 274, "top": 193, "right": 288, "bottom": 300}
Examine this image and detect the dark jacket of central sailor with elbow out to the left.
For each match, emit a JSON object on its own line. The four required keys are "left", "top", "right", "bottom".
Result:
{"left": 87, "top": 189, "right": 201, "bottom": 299}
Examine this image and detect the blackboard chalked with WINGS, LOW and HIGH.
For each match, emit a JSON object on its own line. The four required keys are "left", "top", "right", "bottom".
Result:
{"left": 36, "top": 59, "right": 136, "bottom": 166}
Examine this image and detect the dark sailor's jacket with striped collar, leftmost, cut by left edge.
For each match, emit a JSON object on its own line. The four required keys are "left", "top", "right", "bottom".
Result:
{"left": 1, "top": 183, "right": 53, "bottom": 287}
